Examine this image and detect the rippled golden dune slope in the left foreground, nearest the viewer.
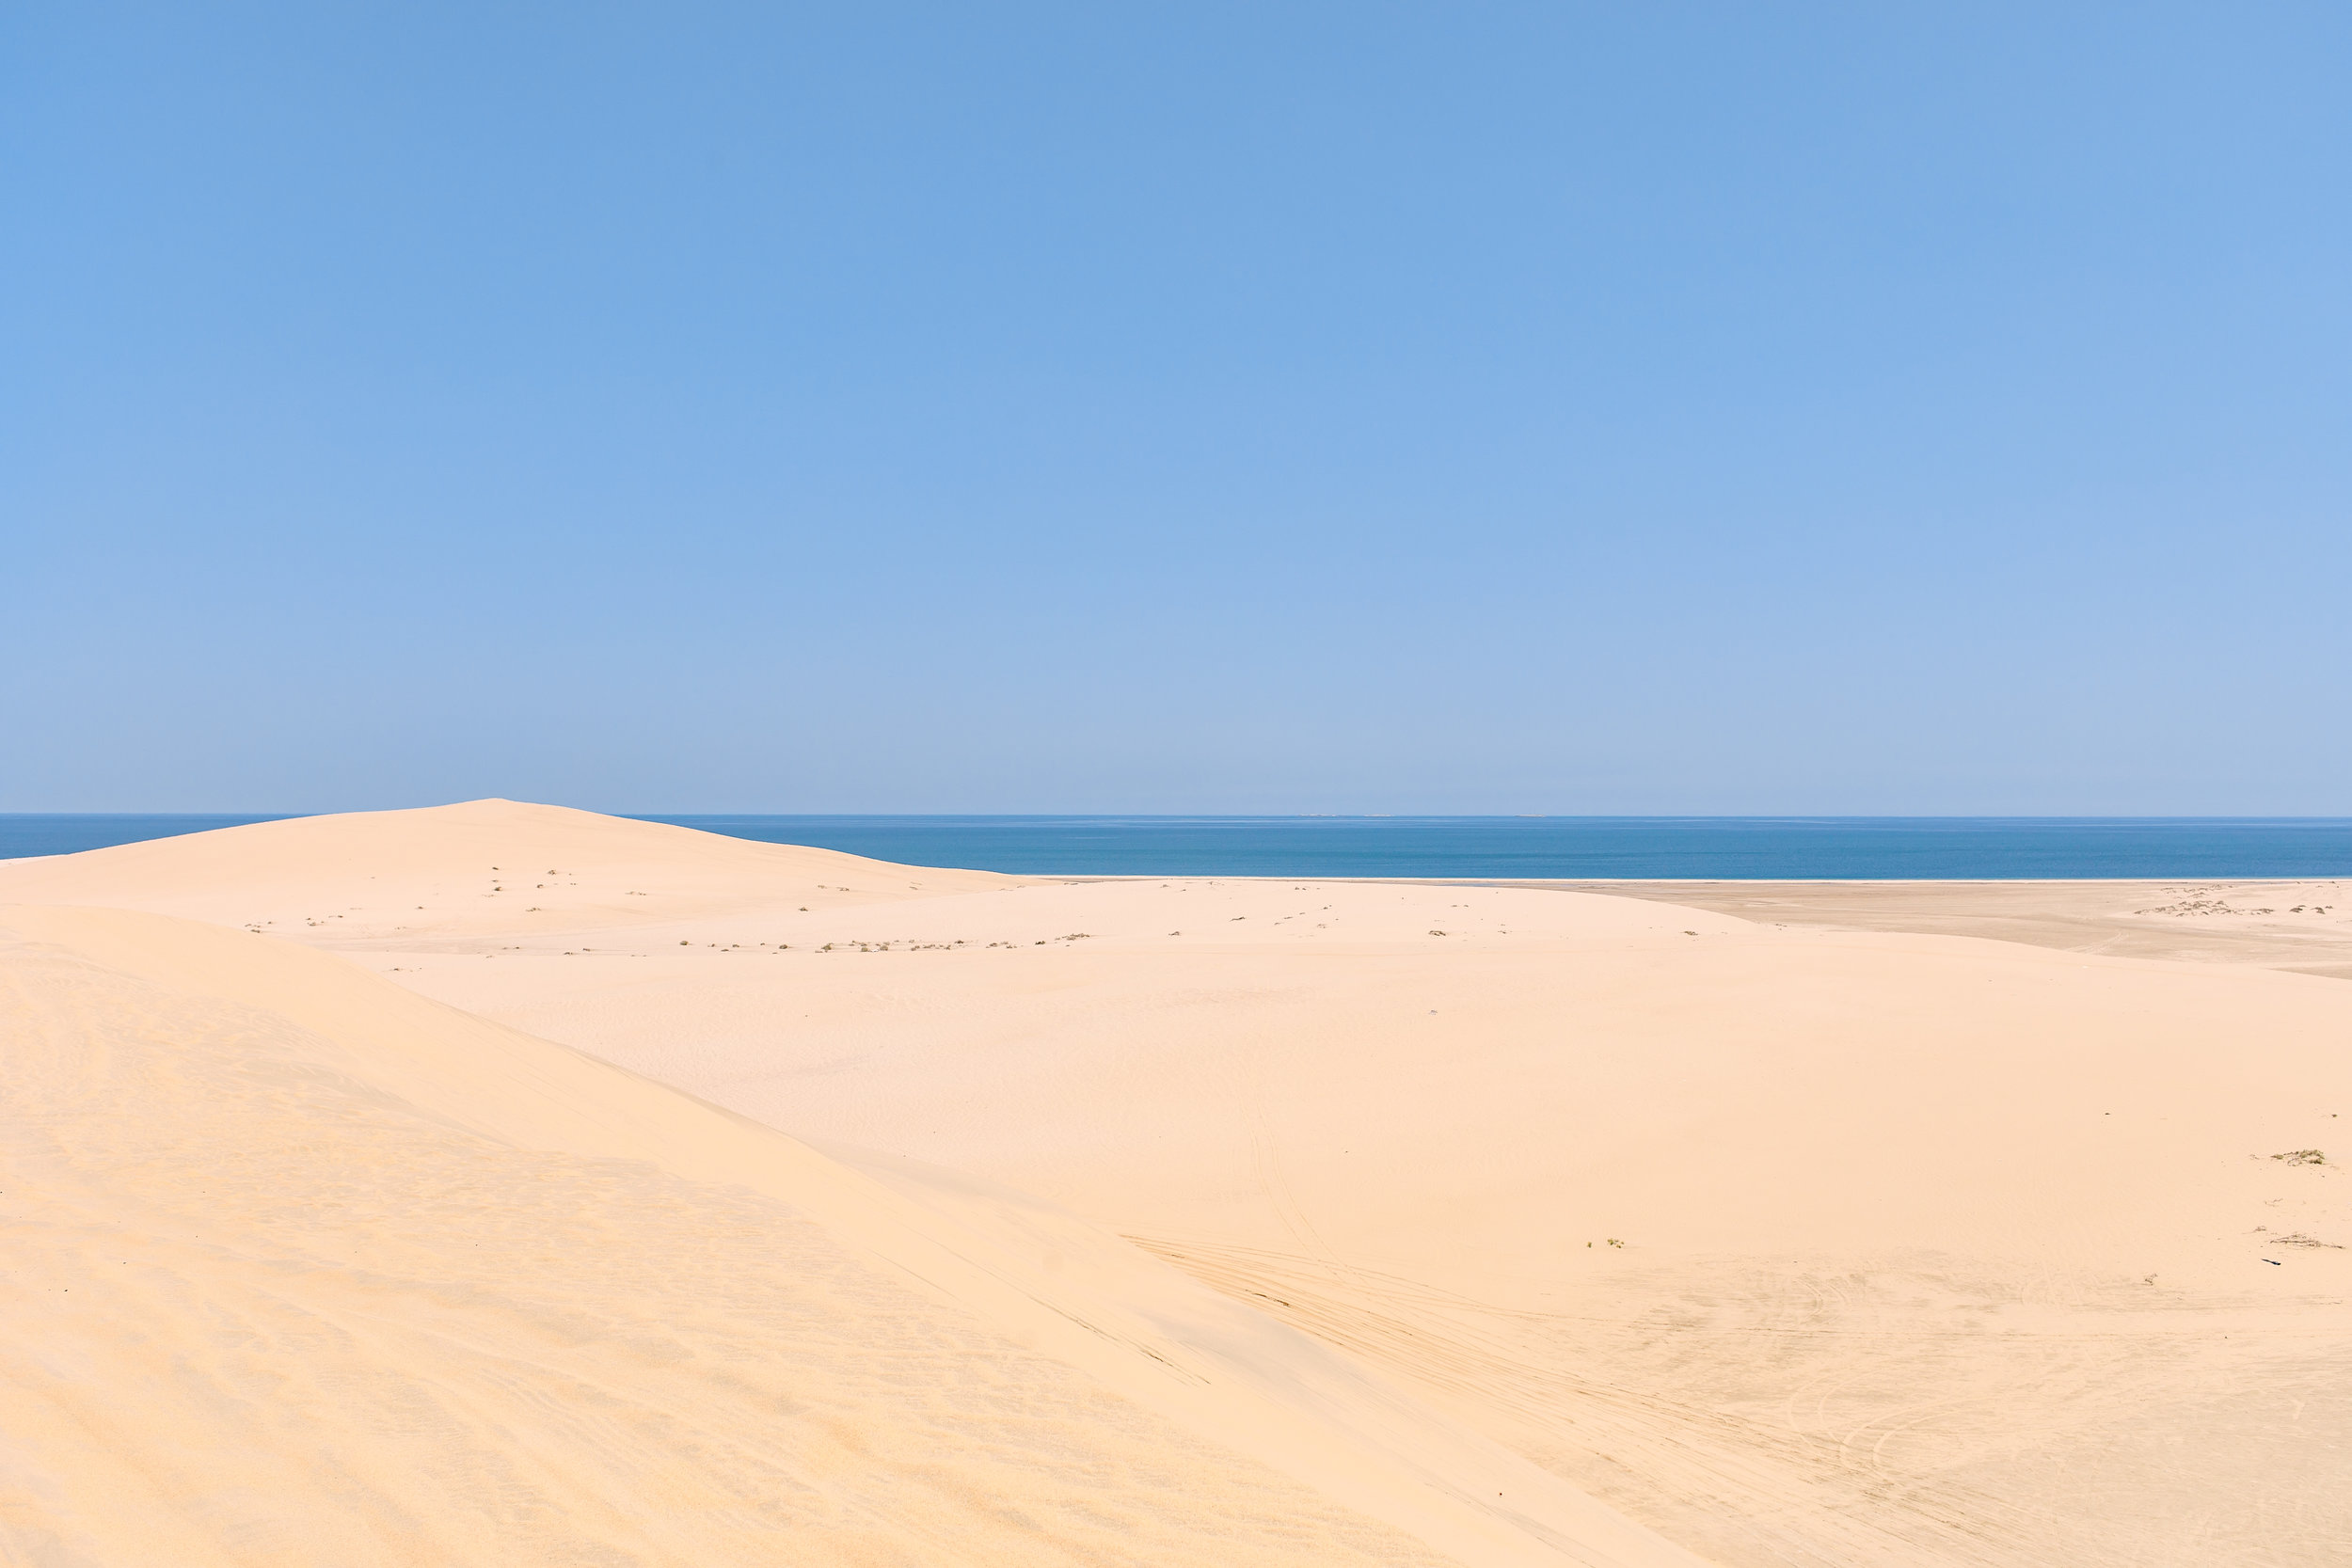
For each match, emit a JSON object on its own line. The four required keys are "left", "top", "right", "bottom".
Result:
{"left": 0, "top": 908, "right": 1692, "bottom": 1568}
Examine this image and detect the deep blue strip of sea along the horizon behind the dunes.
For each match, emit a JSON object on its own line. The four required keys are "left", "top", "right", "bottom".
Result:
{"left": 0, "top": 816, "right": 2352, "bottom": 881}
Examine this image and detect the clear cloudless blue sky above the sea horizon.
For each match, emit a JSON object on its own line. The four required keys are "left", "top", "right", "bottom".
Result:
{"left": 0, "top": 0, "right": 2352, "bottom": 814}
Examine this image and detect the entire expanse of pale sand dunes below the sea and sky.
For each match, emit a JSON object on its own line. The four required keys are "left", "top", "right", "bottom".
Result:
{"left": 0, "top": 801, "right": 2352, "bottom": 1568}
